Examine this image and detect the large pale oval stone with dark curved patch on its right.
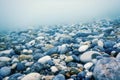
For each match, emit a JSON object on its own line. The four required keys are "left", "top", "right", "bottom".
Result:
{"left": 80, "top": 51, "right": 101, "bottom": 63}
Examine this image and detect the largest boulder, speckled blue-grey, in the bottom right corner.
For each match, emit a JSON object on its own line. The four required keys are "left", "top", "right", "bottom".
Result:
{"left": 93, "top": 57, "right": 120, "bottom": 80}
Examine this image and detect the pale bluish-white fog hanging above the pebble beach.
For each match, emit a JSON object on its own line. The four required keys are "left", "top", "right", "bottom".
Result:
{"left": 0, "top": 0, "right": 120, "bottom": 31}
